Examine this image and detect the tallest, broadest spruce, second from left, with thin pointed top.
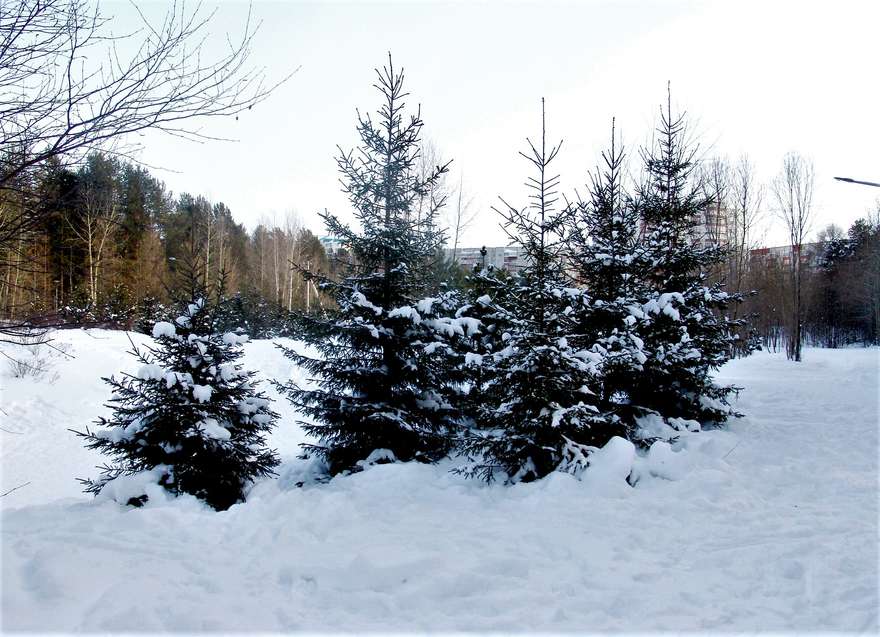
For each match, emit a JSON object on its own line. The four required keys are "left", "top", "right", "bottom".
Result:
{"left": 281, "top": 56, "right": 469, "bottom": 475}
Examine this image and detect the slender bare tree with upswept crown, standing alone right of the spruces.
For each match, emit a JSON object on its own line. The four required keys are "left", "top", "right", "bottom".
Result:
{"left": 772, "top": 153, "right": 815, "bottom": 361}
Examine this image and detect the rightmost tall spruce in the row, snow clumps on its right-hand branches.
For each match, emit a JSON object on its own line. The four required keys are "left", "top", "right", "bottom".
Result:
{"left": 628, "top": 89, "right": 742, "bottom": 424}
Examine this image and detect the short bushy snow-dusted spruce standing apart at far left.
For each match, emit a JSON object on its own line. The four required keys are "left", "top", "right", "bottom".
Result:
{"left": 75, "top": 290, "right": 278, "bottom": 510}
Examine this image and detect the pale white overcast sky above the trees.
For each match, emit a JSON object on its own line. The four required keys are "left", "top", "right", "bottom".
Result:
{"left": 125, "top": 1, "right": 880, "bottom": 246}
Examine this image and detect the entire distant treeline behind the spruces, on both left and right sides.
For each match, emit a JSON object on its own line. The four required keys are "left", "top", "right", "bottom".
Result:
{"left": 0, "top": 147, "right": 880, "bottom": 349}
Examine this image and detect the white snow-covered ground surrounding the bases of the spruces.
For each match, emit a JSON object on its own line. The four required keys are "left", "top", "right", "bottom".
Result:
{"left": 0, "top": 330, "right": 880, "bottom": 633}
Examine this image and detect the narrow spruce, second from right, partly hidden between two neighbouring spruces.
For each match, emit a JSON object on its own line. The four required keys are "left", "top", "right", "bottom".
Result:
{"left": 566, "top": 120, "right": 648, "bottom": 428}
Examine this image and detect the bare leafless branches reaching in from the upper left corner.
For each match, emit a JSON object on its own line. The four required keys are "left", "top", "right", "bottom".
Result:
{"left": 0, "top": 0, "right": 289, "bottom": 334}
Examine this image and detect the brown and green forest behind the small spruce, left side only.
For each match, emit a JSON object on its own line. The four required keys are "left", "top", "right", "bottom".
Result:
{"left": 0, "top": 153, "right": 330, "bottom": 323}
